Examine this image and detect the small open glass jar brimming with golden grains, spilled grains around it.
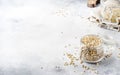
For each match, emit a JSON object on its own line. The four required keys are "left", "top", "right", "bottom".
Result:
{"left": 80, "top": 35, "right": 104, "bottom": 63}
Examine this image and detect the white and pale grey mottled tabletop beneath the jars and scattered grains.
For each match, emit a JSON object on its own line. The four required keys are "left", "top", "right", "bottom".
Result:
{"left": 0, "top": 0, "right": 120, "bottom": 75}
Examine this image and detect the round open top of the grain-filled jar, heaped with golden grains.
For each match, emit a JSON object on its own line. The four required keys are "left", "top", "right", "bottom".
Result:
{"left": 81, "top": 34, "right": 103, "bottom": 47}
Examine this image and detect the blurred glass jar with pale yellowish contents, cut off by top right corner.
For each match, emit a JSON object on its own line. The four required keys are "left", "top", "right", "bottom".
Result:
{"left": 101, "top": 0, "right": 120, "bottom": 24}
